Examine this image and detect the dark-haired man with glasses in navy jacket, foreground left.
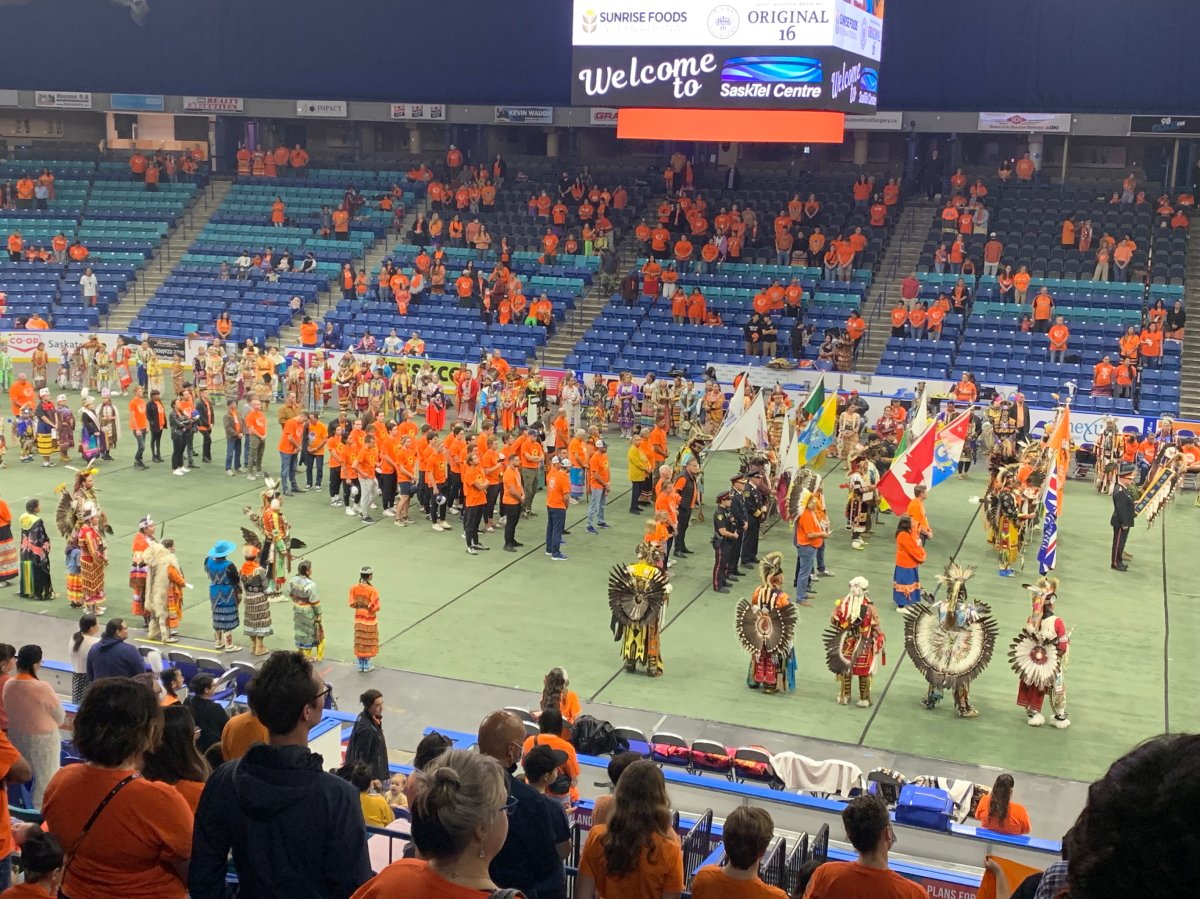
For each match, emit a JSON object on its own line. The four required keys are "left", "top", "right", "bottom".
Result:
{"left": 187, "top": 652, "right": 371, "bottom": 899}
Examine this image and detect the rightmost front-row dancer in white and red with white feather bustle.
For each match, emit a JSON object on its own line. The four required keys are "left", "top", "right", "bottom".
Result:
{"left": 1008, "top": 577, "right": 1070, "bottom": 730}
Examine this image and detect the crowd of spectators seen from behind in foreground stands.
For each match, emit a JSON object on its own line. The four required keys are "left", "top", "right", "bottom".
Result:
{"left": 0, "top": 628, "right": 1200, "bottom": 899}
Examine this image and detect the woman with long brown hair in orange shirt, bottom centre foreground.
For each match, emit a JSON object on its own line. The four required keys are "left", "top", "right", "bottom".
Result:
{"left": 575, "top": 759, "right": 683, "bottom": 899}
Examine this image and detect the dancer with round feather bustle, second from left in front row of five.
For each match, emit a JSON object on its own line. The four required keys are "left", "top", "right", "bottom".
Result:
{"left": 736, "top": 552, "right": 796, "bottom": 693}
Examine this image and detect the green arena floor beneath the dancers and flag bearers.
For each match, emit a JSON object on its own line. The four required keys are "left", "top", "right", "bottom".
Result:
{"left": 0, "top": 381, "right": 1200, "bottom": 780}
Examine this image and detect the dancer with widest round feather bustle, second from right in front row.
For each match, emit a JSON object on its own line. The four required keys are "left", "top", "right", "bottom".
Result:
{"left": 904, "top": 562, "right": 997, "bottom": 718}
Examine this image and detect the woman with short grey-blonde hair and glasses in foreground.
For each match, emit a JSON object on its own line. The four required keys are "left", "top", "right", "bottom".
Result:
{"left": 354, "top": 749, "right": 517, "bottom": 899}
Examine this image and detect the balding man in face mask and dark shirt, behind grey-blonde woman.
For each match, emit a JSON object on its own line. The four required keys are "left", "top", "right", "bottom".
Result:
{"left": 475, "top": 711, "right": 570, "bottom": 899}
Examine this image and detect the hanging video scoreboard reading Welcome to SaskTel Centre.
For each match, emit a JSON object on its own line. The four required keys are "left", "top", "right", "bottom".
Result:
{"left": 571, "top": 0, "right": 883, "bottom": 114}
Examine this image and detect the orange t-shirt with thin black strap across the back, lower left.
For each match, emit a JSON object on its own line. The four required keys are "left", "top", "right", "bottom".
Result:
{"left": 42, "top": 765, "right": 192, "bottom": 899}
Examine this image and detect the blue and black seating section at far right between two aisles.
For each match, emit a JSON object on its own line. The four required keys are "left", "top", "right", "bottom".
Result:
{"left": 912, "top": 181, "right": 1187, "bottom": 415}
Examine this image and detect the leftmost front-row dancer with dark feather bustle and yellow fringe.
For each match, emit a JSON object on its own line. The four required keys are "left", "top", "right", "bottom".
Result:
{"left": 608, "top": 541, "right": 671, "bottom": 677}
